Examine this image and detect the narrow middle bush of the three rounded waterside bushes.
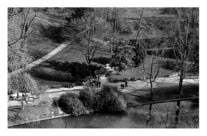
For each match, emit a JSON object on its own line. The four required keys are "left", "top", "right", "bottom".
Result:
{"left": 79, "top": 88, "right": 95, "bottom": 109}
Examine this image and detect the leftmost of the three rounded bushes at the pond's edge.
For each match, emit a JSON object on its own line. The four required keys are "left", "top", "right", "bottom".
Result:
{"left": 58, "top": 93, "right": 87, "bottom": 116}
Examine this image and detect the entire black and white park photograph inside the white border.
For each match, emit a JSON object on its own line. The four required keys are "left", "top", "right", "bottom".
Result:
{"left": 7, "top": 5, "right": 200, "bottom": 130}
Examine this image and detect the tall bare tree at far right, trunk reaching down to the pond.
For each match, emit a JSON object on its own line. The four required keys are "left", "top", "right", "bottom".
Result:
{"left": 171, "top": 8, "right": 199, "bottom": 124}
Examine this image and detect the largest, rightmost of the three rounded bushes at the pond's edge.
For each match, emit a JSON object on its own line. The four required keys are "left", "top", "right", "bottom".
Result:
{"left": 93, "top": 85, "right": 127, "bottom": 113}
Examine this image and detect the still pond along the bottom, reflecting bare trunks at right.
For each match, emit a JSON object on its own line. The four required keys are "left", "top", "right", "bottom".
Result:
{"left": 11, "top": 101, "right": 199, "bottom": 128}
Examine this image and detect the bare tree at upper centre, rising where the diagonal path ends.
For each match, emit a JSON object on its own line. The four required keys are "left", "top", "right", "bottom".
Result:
{"left": 81, "top": 9, "right": 109, "bottom": 74}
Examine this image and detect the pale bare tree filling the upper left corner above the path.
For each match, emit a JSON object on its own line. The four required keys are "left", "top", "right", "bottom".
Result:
{"left": 8, "top": 8, "right": 36, "bottom": 72}
